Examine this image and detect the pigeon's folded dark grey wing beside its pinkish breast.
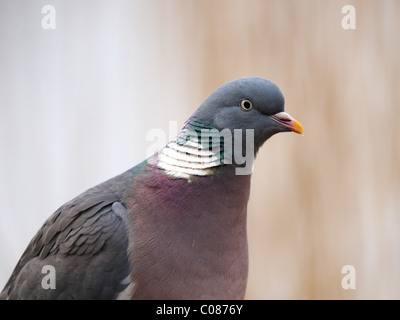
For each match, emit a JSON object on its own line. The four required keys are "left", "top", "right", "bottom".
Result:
{"left": 0, "top": 189, "right": 130, "bottom": 299}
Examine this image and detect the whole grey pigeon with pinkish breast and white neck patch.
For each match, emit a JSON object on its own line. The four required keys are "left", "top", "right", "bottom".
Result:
{"left": 0, "top": 77, "right": 303, "bottom": 300}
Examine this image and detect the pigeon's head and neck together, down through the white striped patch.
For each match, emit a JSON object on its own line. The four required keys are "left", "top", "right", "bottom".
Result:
{"left": 158, "top": 77, "right": 303, "bottom": 180}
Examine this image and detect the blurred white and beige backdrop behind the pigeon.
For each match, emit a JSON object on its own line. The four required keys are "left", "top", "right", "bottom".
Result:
{"left": 0, "top": 0, "right": 400, "bottom": 299}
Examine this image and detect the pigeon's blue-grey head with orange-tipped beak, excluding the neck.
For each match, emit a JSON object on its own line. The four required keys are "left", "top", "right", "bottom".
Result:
{"left": 192, "top": 77, "right": 303, "bottom": 151}
